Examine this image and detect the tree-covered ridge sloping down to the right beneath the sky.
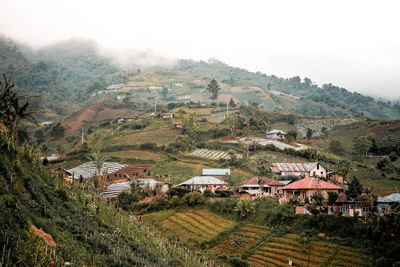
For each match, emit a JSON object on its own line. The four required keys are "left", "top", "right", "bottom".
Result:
{"left": 175, "top": 60, "right": 400, "bottom": 119}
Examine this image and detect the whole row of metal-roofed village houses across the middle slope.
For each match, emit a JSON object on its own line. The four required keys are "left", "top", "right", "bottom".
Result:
{"left": 64, "top": 159, "right": 400, "bottom": 216}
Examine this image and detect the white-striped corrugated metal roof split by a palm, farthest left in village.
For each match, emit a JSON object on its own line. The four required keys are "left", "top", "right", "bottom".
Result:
{"left": 68, "top": 161, "right": 128, "bottom": 179}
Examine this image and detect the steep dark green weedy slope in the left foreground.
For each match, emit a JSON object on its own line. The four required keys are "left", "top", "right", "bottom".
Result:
{"left": 0, "top": 132, "right": 206, "bottom": 266}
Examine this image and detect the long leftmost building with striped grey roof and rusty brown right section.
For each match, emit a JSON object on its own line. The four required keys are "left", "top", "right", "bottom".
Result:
{"left": 66, "top": 161, "right": 151, "bottom": 182}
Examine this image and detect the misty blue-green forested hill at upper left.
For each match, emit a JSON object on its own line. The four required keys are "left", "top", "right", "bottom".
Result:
{"left": 0, "top": 35, "right": 123, "bottom": 118}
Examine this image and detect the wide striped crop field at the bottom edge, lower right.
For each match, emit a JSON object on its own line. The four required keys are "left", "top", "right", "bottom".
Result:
{"left": 247, "top": 234, "right": 372, "bottom": 266}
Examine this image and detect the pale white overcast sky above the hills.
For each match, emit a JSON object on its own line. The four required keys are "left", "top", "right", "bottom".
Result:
{"left": 0, "top": 0, "right": 400, "bottom": 99}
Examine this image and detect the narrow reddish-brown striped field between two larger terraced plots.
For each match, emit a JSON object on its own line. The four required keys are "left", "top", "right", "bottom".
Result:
{"left": 210, "top": 224, "right": 269, "bottom": 255}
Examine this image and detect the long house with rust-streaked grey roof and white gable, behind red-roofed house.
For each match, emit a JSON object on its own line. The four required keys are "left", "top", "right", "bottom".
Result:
{"left": 270, "top": 162, "right": 326, "bottom": 178}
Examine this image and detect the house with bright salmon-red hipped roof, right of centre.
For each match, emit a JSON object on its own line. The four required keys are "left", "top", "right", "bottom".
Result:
{"left": 281, "top": 177, "right": 343, "bottom": 201}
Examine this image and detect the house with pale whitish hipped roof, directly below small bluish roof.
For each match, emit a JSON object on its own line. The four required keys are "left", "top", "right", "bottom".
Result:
{"left": 176, "top": 176, "right": 228, "bottom": 193}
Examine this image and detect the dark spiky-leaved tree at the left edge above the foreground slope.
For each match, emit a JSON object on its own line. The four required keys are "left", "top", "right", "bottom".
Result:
{"left": 0, "top": 74, "right": 37, "bottom": 140}
